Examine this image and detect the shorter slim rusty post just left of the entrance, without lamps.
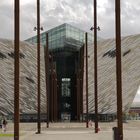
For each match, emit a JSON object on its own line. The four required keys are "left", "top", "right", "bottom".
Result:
{"left": 45, "top": 33, "right": 49, "bottom": 128}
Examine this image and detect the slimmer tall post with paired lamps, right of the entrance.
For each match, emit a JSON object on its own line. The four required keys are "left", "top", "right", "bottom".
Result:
{"left": 94, "top": 0, "right": 98, "bottom": 133}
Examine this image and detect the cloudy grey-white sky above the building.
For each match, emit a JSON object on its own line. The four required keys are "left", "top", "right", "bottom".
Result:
{"left": 0, "top": 0, "right": 140, "bottom": 101}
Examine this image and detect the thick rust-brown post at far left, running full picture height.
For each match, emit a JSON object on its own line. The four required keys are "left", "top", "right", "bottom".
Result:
{"left": 14, "top": 0, "right": 20, "bottom": 140}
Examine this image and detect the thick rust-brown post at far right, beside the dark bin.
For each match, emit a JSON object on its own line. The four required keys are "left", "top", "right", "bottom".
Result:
{"left": 115, "top": 0, "right": 123, "bottom": 140}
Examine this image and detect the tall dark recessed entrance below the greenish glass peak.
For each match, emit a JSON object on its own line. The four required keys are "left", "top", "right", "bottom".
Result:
{"left": 50, "top": 49, "right": 83, "bottom": 121}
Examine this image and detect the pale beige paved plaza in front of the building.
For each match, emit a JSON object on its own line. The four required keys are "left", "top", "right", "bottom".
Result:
{"left": 0, "top": 121, "right": 140, "bottom": 140}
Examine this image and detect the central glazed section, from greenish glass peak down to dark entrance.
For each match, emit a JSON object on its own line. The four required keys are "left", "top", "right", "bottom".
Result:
{"left": 26, "top": 23, "right": 93, "bottom": 121}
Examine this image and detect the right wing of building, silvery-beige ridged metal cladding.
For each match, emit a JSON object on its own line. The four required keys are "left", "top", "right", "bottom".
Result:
{"left": 83, "top": 35, "right": 140, "bottom": 114}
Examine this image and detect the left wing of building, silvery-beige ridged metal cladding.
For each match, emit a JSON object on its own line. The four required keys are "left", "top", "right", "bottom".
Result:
{"left": 0, "top": 39, "right": 46, "bottom": 115}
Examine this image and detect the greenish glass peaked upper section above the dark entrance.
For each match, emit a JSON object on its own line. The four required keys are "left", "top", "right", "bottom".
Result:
{"left": 26, "top": 23, "right": 93, "bottom": 50}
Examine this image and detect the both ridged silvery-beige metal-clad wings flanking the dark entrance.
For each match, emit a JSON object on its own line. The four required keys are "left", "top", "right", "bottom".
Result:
{"left": 0, "top": 35, "right": 140, "bottom": 115}
